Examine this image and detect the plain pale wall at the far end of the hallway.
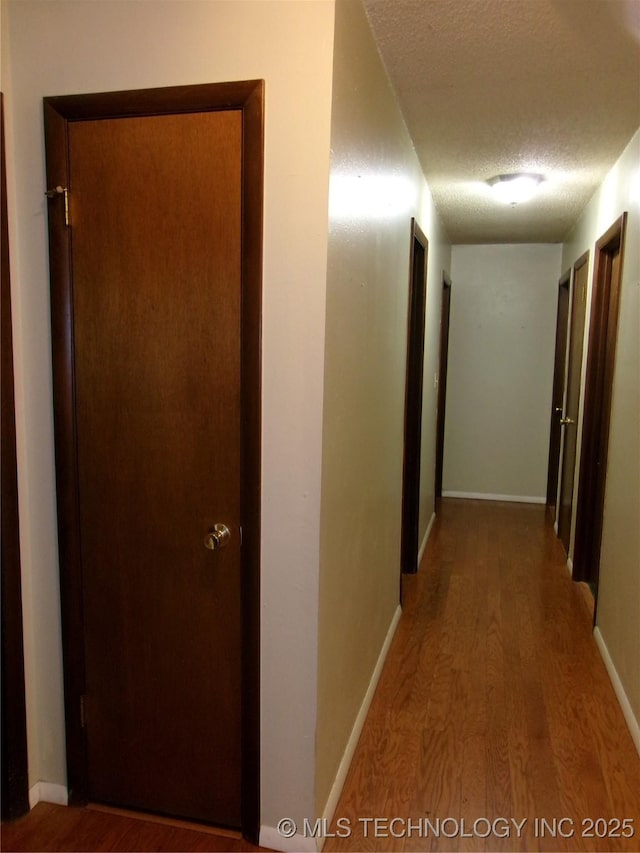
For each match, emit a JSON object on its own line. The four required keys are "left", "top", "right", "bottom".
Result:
{"left": 443, "top": 244, "right": 561, "bottom": 502}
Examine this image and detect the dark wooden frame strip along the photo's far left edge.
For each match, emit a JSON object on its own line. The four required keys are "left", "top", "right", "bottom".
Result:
{"left": 0, "top": 93, "right": 29, "bottom": 819}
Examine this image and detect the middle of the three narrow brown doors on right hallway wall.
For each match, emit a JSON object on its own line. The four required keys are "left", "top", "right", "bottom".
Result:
{"left": 558, "top": 253, "right": 589, "bottom": 554}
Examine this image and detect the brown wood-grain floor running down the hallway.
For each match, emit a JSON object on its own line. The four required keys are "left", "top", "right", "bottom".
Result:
{"left": 324, "top": 499, "right": 640, "bottom": 851}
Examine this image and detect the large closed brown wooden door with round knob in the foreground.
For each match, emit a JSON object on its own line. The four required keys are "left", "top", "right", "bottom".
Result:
{"left": 48, "top": 87, "right": 258, "bottom": 827}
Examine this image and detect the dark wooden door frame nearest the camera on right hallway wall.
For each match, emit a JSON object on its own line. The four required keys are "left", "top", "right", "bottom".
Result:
{"left": 573, "top": 212, "right": 627, "bottom": 606}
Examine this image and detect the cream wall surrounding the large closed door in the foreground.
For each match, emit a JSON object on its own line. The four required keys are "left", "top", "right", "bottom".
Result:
{"left": 2, "top": 0, "right": 334, "bottom": 825}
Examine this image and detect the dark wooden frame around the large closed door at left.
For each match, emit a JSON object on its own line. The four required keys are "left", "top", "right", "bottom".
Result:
{"left": 44, "top": 80, "right": 264, "bottom": 844}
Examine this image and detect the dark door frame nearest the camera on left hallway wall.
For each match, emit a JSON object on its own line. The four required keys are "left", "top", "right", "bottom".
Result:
{"left": 400, "top": 218, "right": 429, "bottom": 574}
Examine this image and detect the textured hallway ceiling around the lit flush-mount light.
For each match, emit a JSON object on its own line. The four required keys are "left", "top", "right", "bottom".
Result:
{"left": 364, "top": 0, "right": 640, "bottom": 243}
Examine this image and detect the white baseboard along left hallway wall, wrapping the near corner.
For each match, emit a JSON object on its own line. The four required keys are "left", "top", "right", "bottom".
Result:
{"left": 260, "top": 604, "right": 400, "bottom": 853}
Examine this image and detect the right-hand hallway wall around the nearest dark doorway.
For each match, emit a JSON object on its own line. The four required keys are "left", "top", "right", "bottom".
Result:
{"left": 562, "top": 130, "right": 640, "bottom": 732}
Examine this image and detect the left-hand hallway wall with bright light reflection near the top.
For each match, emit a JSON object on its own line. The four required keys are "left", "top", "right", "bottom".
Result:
{"left": 316, "top": 0, "right": 450, "bottom": 815}
